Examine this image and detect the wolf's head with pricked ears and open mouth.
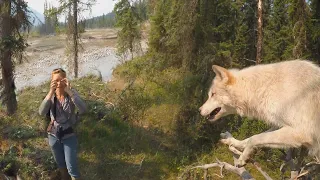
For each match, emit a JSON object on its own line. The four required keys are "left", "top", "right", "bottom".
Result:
{"left": 199, "top": 65, "right": 236, "bottom": 121}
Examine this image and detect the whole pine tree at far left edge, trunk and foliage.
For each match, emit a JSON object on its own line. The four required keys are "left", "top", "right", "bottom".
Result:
{"left": 0, "top": 0, "right": 31, "bottom": 115}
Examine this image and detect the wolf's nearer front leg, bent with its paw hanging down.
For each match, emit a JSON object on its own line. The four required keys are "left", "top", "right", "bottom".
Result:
{"left": 238, "top": 127, "right": 311, "bottom": 166}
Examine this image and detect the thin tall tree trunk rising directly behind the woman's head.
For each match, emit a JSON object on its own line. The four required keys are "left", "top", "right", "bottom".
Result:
{"left": 73, "top": 0, "right": 78, "bottom": 78}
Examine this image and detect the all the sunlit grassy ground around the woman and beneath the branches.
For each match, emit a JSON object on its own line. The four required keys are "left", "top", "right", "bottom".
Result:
{"left": 0, "top": 64, "right": 288, "bottom": 180}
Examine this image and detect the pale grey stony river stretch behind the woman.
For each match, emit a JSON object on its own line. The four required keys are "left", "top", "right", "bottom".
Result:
{"left": 15, "top": 48, "right": 120, "bottom": 91}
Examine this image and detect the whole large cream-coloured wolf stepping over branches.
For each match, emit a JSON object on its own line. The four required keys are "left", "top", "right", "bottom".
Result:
{"left": 200, "top": 60, "right": 320, "bottom": 165}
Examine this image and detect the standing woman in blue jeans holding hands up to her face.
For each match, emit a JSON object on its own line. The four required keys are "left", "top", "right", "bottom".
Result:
{"left": 39, "top": 68, "right": 86, "bottom": 180}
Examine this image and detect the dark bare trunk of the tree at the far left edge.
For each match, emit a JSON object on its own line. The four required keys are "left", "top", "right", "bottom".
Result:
{"left": 0, "top": 0, "right": 17, "bottom": 115}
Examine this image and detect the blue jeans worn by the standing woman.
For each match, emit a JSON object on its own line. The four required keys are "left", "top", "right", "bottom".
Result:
{"left": 48, "top": 134, "right": 80, "bottom": 178}
